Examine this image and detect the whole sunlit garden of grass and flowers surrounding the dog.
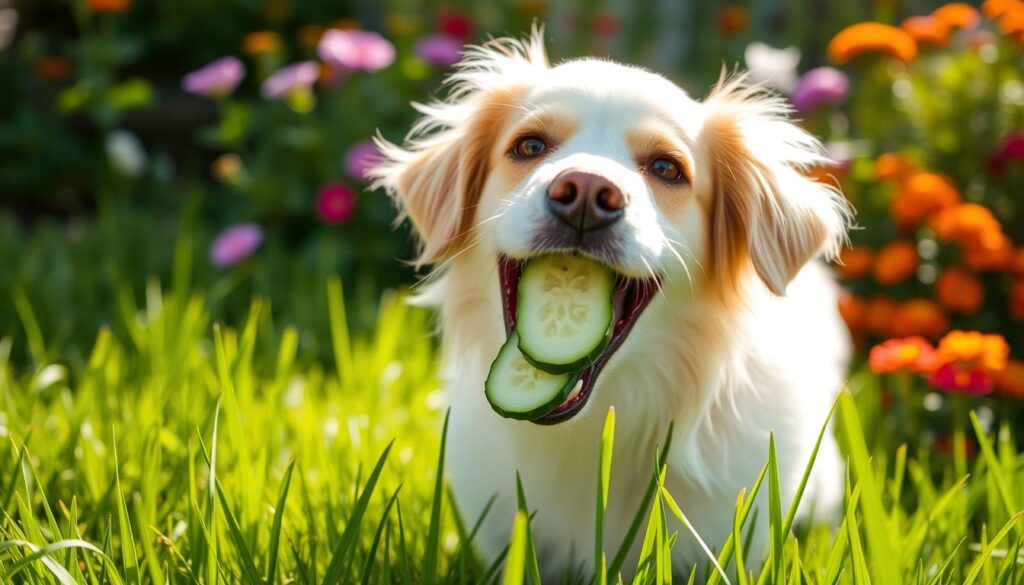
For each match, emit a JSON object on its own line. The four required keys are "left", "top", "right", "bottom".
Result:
{"left": 0, "top": 0, "right": 1024, "bottom": 583}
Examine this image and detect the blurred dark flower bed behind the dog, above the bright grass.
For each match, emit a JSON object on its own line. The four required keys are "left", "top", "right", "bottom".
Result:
{"left": 0, "top": 0, "right": 1024, "bottom": 413}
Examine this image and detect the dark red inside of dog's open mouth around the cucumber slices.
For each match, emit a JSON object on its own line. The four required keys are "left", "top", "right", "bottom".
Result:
{"left": 498, "top": 256, "right": 660, "bottom": 424}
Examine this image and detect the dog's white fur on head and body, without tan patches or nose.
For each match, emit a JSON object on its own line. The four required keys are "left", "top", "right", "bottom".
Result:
{"left": 375, "top": 28, "right": 849, "bottom": 576}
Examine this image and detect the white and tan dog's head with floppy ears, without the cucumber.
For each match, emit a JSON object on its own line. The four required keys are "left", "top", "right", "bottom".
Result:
{"left": 373, "top": 32, "right": 849, "bottom": 422}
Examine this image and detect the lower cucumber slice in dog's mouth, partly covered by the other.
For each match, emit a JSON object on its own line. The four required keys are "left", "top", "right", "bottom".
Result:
{"left": 484, "top": 332, "right": 580, "bottom": 420}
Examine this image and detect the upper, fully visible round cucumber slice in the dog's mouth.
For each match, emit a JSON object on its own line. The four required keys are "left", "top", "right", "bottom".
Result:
{"left": 516, "top": 255, "right": 615, "bottom": 374}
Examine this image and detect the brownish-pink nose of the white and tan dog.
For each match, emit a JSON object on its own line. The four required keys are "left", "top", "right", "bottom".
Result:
{"left": 548, "top": 169, "right": 626, "bottom": 232}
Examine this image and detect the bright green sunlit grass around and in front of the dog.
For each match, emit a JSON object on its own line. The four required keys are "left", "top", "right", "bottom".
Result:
{"left": 0, "top": 272, "right": 1024, "bottom": 584}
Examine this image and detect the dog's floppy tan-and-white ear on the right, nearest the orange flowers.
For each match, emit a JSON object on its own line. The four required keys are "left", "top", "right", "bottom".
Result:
{"left": 698, "top": 77, "right": 852, "bottom": 295}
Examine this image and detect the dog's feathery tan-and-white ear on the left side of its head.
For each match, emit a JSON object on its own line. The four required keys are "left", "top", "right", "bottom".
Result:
{"left": 370, "top": 28, "right": 548, "bottom": 265}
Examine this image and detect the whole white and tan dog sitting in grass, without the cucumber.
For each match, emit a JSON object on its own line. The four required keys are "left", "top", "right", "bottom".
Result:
{"left": 372, "top": 29, "right": 852, "bottom": 578}
